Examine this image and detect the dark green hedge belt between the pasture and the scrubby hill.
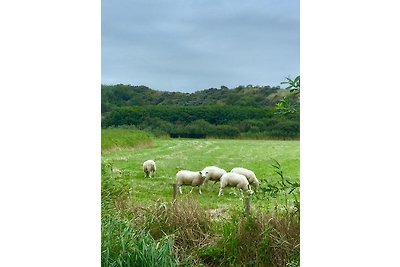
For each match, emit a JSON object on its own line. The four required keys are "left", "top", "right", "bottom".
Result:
{"left": 102, "top": 106, "right": 300, "bottom": 138}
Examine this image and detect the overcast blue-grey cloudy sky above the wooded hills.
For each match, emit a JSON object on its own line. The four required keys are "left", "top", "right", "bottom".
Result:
{"left": 101, "top": 0, "right": 300, "bottom": 92}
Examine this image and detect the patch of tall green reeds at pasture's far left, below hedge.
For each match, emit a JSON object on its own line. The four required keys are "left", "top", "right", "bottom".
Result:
{"left": 101, "top": 128, "right": 153, "bottom": 151}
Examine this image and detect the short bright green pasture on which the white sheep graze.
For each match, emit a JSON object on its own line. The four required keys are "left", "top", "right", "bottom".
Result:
{"left": 102, "top": 139, "right": 300, "bottom": 208}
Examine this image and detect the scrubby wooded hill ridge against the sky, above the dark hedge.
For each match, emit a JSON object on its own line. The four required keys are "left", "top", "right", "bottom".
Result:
{"left": 101, "top": 84, "right": 287, "bottom": 114}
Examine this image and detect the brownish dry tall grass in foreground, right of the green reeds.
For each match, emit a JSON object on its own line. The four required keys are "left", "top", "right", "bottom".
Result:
{"left": 108, "top": 199, "right": 300, "bottom": 267}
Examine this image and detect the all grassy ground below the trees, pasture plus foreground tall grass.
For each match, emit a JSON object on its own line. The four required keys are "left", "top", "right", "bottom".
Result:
{"left": 101, "top": 129, "right": 300, "bottom": 266}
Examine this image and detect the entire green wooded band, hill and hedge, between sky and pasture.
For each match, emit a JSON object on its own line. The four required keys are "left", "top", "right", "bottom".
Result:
{"left": 101, "top": 81, "right": 300, "bottom": 138}
